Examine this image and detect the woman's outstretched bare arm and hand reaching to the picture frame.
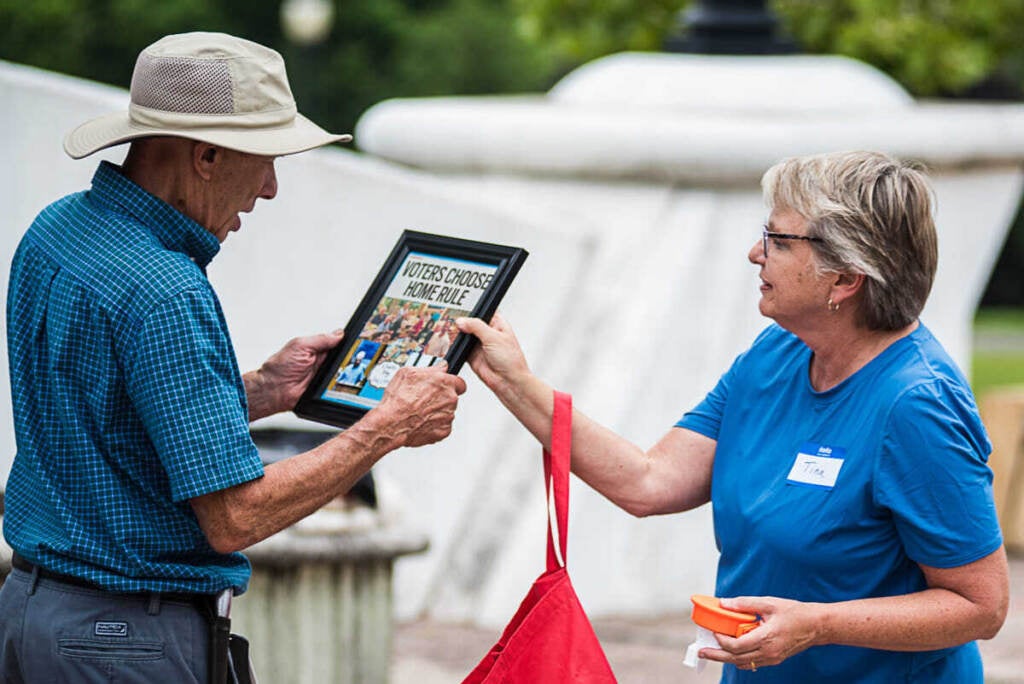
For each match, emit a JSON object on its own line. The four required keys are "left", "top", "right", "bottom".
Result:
{"left": 457, "top": 314, "right": 716, "bottom": 516}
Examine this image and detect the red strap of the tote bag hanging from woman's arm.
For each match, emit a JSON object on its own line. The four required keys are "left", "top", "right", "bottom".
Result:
{"left": 544, "top": 391, "right": 572, "bottom": 572}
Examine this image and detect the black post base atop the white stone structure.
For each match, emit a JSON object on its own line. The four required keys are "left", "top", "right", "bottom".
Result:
{"left": 665, "top": 0, "right": 797, "bottom": 54}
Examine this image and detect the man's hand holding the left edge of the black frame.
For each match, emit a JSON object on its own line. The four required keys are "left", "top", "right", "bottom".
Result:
{"left": 243, "top": 330, "right": 344, "bottom": 421}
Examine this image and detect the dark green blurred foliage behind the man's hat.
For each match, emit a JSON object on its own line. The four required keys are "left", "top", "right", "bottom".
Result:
{"left": 0, "top": 0, "right": 555, "bottom": 131}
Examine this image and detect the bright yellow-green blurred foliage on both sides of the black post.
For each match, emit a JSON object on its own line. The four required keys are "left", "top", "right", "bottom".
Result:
{"left": 515, "top": 0, "right": 1024, "bottom": 95}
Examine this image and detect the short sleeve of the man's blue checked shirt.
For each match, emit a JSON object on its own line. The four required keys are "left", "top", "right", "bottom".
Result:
{"left": 125, "top": 289, "right": 263, "bottom": 501}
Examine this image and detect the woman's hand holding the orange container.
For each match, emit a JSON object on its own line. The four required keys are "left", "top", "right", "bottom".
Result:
{"left": 700, "top": 596, "right": 822, "bottom": 670}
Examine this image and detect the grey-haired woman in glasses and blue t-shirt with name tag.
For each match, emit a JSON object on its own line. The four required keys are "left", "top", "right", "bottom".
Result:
{"left": 459, "top": 153, "right": 1009, "bottom": 684}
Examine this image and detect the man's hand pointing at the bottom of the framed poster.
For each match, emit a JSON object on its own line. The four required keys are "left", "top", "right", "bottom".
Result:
{"left": 360, "top": 361, "right": 466, "bottom": 446}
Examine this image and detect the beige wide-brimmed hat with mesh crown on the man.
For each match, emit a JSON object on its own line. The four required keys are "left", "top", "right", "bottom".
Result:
{"left": 63, "top": 33, "right": 352, "bottom": 159}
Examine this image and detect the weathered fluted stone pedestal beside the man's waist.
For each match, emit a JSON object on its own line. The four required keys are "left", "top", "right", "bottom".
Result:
{"left": 231, "top": 510, "right": 427, "bottom": 684}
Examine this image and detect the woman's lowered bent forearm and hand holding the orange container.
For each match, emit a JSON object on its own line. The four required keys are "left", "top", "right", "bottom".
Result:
{"left": 701, "top": 548, "right": 1010, "bottom": 670}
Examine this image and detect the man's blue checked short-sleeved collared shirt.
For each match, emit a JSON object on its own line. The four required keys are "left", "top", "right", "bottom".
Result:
{"left": 4, "top": 162, "right": 263, "bottom": 594}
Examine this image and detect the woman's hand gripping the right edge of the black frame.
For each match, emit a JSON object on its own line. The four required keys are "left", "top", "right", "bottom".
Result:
{"left": 455, "top": 313, "right": 529, "bottom": 397}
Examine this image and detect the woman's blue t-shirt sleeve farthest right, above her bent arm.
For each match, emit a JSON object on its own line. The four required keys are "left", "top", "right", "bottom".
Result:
{"left": 873, "top": 381, "right": 1002, "bottom": 568}
